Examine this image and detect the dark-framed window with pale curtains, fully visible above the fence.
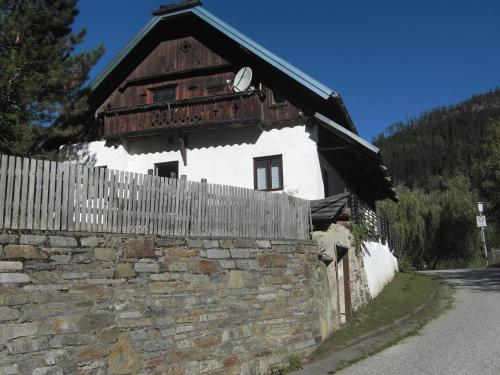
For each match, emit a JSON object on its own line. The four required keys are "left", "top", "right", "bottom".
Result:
{"left": 253, "top": 155, "right": 283, "bottom": 191}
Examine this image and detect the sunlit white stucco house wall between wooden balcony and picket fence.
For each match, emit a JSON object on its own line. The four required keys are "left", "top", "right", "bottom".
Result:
{"left": 89, "top": 125, "right": 336, "bottom": 199}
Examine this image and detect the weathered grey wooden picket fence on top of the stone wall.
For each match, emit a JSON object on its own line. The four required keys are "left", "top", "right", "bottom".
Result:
{"left": 0, "top": 155, "right": 310, "bottom": 239}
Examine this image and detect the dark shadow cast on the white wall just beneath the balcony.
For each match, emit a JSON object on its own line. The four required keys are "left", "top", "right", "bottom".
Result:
{"left": 125, "top": 126, "right": 317, "bottom": 155}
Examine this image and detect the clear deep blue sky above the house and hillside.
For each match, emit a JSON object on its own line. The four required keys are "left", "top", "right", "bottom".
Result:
{"left": 75, "top": 0, "right": 500, "bottom": 140}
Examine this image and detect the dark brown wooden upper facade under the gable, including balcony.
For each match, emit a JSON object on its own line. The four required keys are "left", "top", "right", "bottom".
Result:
{"left": 97, "top": 36, "right": 303, "bottom": 139}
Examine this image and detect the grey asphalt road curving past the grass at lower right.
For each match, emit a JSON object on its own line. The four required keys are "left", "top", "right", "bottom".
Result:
{"left": 336, "top": 269, "right": 500, "bottom": 375}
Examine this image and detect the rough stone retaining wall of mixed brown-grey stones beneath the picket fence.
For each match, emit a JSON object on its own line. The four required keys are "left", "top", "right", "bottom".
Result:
{"left": 0, "top": 232, "right": 324, "bottom": 375}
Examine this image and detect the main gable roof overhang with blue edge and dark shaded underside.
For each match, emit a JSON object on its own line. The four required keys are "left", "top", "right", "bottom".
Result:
{"left": 91, "top": 6, "right": 356, "bottom": 133}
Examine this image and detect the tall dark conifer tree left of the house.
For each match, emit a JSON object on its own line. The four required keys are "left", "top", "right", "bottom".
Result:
{"left": 0, "top": 0, "right": 103, "bottom": 155}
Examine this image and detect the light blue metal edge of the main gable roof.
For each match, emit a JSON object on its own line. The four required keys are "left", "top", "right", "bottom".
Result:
{"left": 90, "top": 1, "right": 339, "bottom": 100}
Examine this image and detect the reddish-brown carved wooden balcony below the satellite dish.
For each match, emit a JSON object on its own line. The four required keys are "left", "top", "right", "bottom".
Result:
{"left": 99, "top": 90, "right": 262, "bottom": 138}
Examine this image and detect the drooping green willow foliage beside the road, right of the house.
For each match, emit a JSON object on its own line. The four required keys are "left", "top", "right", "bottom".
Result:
{"left": 379, "top": 176, "right": 480, "bottom": 269}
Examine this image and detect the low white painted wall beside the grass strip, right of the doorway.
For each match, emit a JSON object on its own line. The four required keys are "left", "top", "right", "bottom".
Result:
{"left": 363, "top": 242, "right": 398, "bottom": 298}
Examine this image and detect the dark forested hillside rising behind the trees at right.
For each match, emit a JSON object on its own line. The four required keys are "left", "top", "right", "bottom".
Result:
{"left": 373, "top": 89, "right": 500, "bottom": 187}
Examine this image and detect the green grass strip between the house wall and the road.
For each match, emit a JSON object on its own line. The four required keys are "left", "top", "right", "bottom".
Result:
{"left": 313, "top": 272, "right": 441, "bottom": 359}
